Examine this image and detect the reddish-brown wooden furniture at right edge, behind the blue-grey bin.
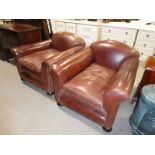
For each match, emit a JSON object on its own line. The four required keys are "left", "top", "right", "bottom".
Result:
{"left": 135, "top": 56, "right": 155, "bottom": 98}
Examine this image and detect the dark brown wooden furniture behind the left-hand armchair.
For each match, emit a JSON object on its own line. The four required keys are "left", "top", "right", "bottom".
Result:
{"left": 0, "top": 23, "right": 42, "bottom": 62}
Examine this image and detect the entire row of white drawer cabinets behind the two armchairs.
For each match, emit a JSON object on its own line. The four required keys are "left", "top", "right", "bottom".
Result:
{"left": 49, "top": 20, "right": 155, "bottom": 58}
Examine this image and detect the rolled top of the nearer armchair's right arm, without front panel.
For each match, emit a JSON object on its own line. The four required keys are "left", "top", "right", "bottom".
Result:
{"left": 104, "top": 57, "right": 139, "bottom": 101}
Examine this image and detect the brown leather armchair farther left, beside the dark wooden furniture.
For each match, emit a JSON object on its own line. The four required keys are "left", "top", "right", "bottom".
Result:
{"left": 11, "top": 32, "right": 85, "bottom": 94}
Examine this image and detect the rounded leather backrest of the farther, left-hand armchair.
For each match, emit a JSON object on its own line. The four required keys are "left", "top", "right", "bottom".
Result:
{"left": 52, "top": 32, "right": 86, "bottom": 51}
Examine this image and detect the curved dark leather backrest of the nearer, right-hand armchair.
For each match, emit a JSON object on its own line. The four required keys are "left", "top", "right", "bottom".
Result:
{"left": 90, "top": 40, "right": 138, "bottom": 70}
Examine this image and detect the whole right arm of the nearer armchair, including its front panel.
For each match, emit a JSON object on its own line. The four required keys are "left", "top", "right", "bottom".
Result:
{"left": 103, "top": 57, "right": 139, "bottom": 128}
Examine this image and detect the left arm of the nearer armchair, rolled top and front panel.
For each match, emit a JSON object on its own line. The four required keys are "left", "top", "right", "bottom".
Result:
{"left": 51, "top": 48, "right": 93, "bottom": 99}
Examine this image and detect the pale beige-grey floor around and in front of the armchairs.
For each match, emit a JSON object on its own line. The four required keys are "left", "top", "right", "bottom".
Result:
{"left": 0, "top": 60, "right": 144, "bottom": 135}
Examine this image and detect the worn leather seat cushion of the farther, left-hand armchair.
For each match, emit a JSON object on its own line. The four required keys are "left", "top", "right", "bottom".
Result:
{"left": 19, "top": 48, "right": 60, "bottom": 72}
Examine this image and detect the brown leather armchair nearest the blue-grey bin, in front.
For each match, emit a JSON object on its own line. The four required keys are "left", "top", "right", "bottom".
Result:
{"left": 51, "top": 41, "right": 139, "bottom": 131}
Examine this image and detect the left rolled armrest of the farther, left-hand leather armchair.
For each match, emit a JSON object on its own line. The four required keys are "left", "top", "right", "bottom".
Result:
{"left": 11, "top": 39, "right": 52, "bottom": 58}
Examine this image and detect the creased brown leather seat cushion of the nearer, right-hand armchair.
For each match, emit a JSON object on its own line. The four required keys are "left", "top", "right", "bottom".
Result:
{"left": 61, "top": 63, "right": 115, "bottom": 116}
